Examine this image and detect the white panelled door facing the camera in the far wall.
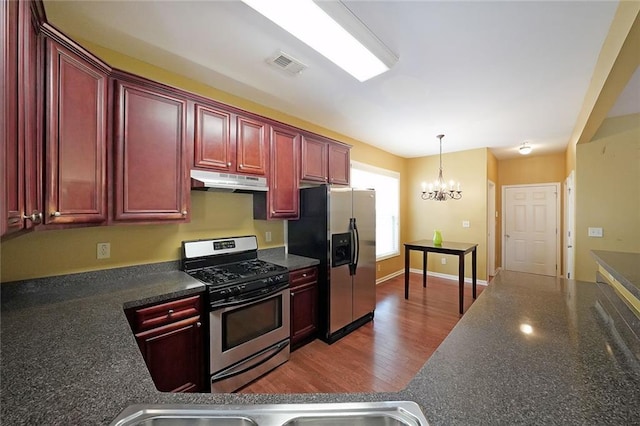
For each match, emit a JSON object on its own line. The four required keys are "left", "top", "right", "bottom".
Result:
{"left": 503, "top": 184, "right": 559, "bottom": 276}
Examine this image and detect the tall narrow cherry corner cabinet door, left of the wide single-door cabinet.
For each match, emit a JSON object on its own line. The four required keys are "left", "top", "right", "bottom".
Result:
{"left": 45, "top": 40, "right": 108, "bottom": 223}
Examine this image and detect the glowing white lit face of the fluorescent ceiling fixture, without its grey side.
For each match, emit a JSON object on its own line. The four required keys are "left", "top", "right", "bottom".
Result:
{"left": 243, "top": 0, "right": 397, "bottom": 81}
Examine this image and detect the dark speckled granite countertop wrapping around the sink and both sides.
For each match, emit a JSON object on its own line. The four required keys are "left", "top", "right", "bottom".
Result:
{"left": 0, "top": 264, "right": 640, "bottom": 425}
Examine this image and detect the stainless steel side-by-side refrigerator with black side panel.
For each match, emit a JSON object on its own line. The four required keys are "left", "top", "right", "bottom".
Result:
{"left": 287, "top": 185, "right": 376, "bottom": 343}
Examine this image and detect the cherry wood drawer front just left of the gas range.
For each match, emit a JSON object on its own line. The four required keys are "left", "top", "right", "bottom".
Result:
{"left": 134, "top": 295, "right": 201, "bottom": 333}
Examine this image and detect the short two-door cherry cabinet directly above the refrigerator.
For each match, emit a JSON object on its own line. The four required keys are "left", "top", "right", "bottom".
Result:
{"left": 300, "top": 135, "right": 351, "bottom": 185}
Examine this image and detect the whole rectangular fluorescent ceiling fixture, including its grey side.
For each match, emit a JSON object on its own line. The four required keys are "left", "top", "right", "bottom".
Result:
{"left": 242, "top": 0, "right": 398, "bottom": 81}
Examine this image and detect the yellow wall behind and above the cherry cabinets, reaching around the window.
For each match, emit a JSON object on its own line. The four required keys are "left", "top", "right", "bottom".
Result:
{"left": 0, "top": 38, "right": 407, "bottom": 282}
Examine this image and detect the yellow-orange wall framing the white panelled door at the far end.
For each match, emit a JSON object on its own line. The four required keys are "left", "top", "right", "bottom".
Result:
{"left": 496, "top": 153, "right": 565, "bottom": 266}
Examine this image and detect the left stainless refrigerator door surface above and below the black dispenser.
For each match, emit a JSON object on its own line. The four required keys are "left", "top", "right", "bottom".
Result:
{"left": 328, "top": 188, "right": 353, "bottom": 334}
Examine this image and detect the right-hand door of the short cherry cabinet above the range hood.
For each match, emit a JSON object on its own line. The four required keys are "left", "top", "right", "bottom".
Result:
{"left": 236, "top": 116, "right": 268, "bottom": 176}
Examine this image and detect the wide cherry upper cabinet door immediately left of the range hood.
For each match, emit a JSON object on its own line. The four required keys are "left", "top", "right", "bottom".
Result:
{"left": 114, "top": 81, "right": 189, "bottom": 222}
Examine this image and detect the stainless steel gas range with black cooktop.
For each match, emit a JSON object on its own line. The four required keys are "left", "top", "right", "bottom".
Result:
{"left": 182, "top": 236, "right": 290, "bottom": 392}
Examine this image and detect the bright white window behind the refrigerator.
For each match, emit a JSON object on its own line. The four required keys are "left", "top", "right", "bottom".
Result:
{"left": 351, "top": 161, "right": 400, "bottom": 260}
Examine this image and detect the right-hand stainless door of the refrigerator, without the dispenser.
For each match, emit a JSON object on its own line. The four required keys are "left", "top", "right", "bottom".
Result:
{"left": 353, "top": 189, "right": 376, "bottom": 321}
